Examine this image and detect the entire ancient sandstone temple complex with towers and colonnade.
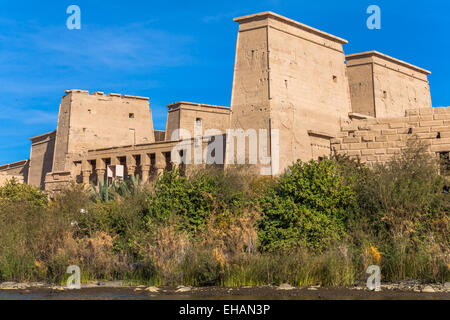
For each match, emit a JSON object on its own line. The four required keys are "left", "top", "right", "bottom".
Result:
{"left": 0, "top": 12, "right": 450, "bottom": 191}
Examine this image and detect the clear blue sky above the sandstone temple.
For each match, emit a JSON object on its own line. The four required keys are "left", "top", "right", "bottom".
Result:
{"left": 0, "top": 0, "right": 450, "bottom": 164}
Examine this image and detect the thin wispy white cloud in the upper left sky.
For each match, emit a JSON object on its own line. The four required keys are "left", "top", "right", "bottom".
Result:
{"left": 0, "top": 20, "right": 195, "bottom": 94}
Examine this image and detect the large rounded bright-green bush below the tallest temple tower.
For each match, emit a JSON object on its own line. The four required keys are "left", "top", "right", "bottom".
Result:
{"left": 259, "top": 160, "right": 356, "bottom": 251}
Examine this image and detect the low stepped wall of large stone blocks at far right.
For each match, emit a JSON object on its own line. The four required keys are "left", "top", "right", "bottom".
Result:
{"left": 331, "top": 107, "right": 450, "bottom": 165}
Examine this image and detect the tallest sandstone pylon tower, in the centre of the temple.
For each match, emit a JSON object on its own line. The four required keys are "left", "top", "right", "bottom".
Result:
{"left": 231, "top": 12, "right": 351, "bottom": 174}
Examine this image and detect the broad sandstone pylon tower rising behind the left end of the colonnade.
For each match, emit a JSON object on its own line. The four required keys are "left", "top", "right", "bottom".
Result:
{"left": 53, "top": 90, "right": 155, "bottom": 172}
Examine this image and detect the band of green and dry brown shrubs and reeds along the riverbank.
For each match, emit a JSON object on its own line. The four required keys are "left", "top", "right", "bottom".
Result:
{"left": 0, "top": 142, "right": 450, "bottom": 286}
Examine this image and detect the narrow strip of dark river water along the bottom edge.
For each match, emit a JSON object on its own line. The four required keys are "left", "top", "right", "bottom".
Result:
{"left": 0, "top": 288, "right": 450, "bottom": 300}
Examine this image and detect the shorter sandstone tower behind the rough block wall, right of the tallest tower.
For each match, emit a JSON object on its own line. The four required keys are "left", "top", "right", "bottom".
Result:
{"left": 346, "top": 51, "right": 432, "bottom": 118}
